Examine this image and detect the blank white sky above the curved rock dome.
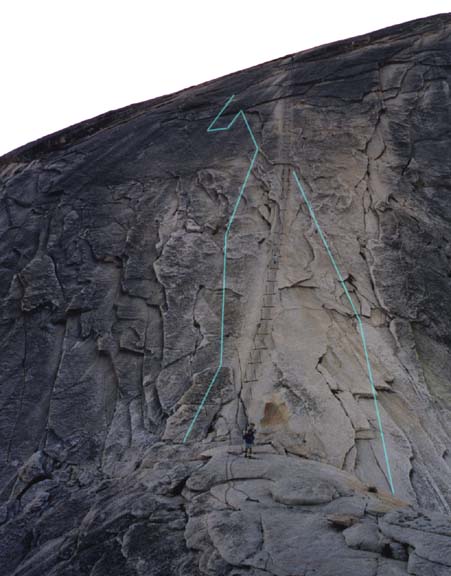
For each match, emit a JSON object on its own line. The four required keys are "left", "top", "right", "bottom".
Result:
{"left": 0, "top": 0, "right": 451, "bottom": 155}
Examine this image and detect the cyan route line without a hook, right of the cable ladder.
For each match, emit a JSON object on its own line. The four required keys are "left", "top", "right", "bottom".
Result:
{"left": 293, "top": 170, "right": 395, "bottom": 494}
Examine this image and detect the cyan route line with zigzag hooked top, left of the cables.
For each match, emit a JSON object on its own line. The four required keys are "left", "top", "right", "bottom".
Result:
{"left": 183, "top": 94, "right": 259, "bottom": 443}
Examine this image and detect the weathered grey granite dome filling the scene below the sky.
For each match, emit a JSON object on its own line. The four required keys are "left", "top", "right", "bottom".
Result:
{"left": 0, "top": 15, "right": 451, "bottom": 576}
